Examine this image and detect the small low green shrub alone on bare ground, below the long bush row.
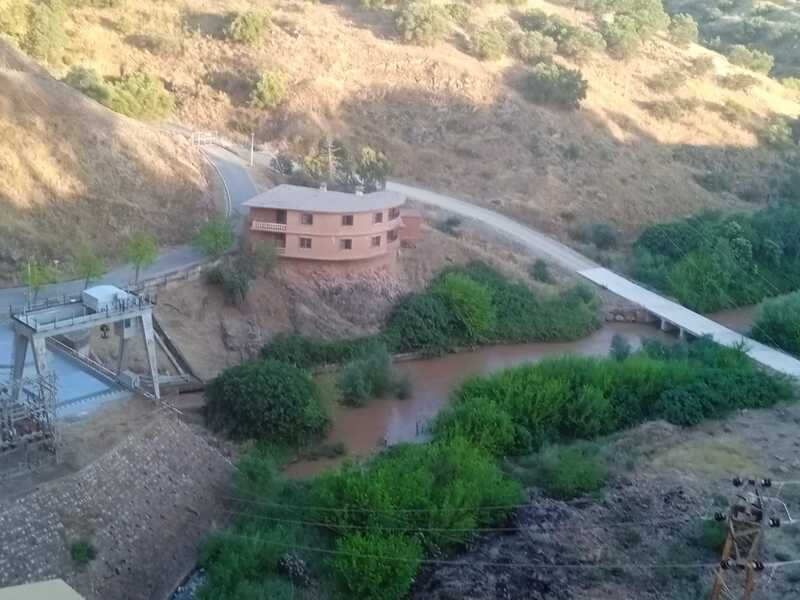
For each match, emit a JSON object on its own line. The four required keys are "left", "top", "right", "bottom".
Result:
{"left": 536, "top": 446, "right": 607, "bottom": 500}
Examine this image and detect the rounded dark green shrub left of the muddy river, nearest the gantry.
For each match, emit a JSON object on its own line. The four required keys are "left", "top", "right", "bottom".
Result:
{"left": 205, "top": 360, "right": 328, "bottom": 443}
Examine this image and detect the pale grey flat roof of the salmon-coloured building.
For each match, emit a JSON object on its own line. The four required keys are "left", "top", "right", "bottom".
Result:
{"left": 244, "top": 184, "right": 405, "bottom": 213}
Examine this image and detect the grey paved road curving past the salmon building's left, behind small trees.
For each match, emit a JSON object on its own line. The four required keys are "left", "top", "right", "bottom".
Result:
{"left": 0, "top": 146, "right": 258, "bottom": 318}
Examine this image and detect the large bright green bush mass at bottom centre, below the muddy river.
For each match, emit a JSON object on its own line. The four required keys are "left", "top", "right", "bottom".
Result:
{"left": 308, "top": 439, "right": 522, "bottom": 551}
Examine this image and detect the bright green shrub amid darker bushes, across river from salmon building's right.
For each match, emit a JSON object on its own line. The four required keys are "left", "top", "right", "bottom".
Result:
{"left": 433, "top": 272, "right": 497, "bottom": 342}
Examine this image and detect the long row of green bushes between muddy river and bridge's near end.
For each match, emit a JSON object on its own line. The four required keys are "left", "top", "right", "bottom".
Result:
{"left": 434, "top": 339, "right": 792, "bottom": 455}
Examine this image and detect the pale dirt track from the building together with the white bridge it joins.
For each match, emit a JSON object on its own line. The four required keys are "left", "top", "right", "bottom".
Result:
{"left": 386, "top": 182, "right": 800, "bottom": 378}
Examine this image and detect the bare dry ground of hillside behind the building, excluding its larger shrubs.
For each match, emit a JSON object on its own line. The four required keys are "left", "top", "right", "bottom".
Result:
{"left": 43, "top": 0, "right": 800, "bottom": 244}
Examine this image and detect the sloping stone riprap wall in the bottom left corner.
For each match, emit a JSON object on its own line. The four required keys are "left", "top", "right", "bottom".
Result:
{"left": 0, "top": 413, "right": 232, "bottom": 600}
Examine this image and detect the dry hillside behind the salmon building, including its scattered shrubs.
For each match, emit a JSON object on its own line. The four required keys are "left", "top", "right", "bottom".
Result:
{"left": 0, "top": 0, "right": 800, "bottom": 251}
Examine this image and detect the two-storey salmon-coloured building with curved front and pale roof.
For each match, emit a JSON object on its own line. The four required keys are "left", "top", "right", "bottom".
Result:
{"left": 244, "top": 184, "right": 419, "bottom": 262}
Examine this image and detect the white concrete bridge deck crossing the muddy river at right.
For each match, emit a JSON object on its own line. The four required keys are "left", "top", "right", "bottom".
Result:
{"left": 578, "top": 268, "right": 800, "bottom": 377}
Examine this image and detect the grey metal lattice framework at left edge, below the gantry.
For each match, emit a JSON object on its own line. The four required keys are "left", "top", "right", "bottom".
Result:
{"left": 0, "top": 373, "right": 61, "bottom": 480}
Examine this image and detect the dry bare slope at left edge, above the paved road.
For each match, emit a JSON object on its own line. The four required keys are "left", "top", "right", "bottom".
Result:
{"left": 0, "top": 41, "right": 210, "bottom": 282}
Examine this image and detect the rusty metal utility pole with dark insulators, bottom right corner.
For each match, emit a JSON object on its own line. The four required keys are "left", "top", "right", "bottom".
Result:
{"left": 710, "top": 477, "right": 781, "bottom": 600}
